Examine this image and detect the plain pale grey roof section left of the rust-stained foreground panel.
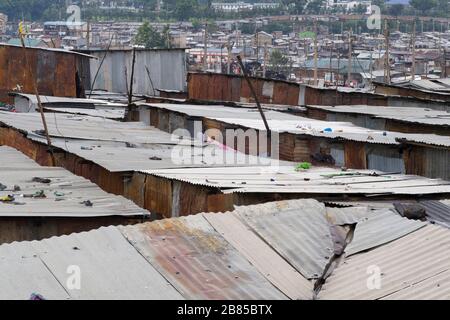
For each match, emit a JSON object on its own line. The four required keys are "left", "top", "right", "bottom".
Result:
{"left": 0, "top": 227, "right": 182, "bottom": 299}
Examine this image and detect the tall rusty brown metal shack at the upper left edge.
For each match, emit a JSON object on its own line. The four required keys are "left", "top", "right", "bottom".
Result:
{"left": 0, "top": 44, "right": 94, "bottom": 103}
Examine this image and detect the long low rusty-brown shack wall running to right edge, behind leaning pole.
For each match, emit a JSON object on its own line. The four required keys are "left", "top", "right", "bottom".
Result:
{"left": 188, "top": 72, "right": 450, "bottom": 111}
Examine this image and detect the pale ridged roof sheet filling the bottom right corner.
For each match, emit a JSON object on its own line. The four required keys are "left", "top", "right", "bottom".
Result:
{"left": 318, "top": 225, "right": 450, "bottom": 299}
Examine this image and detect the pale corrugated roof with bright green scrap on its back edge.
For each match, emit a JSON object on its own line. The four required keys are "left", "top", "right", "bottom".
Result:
{"left": 142, "top": 166, "right": 450, "bottom": 195}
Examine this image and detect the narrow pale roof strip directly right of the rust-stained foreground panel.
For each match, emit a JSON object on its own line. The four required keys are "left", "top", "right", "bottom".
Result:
{"left": 204, "top": 211, "right": 313, "bottom": 300}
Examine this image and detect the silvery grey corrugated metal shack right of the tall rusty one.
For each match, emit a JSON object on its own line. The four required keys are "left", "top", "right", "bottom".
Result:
{"left": 80, "top": 49, "right": 187, "bottom": 96}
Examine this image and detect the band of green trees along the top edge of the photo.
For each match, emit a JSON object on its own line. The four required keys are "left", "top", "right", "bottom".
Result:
{"left": 0, "top": 0, "right": 450, "bottom": 21}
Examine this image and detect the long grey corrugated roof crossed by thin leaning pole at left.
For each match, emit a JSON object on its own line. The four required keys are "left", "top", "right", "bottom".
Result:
{"left": 0, "top": 112, "right": 261, "bottom": 172}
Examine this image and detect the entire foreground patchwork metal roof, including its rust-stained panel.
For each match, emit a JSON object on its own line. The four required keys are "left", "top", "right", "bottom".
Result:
{"left": 0, "top": 199, "right": 450, "bottom": 300}
